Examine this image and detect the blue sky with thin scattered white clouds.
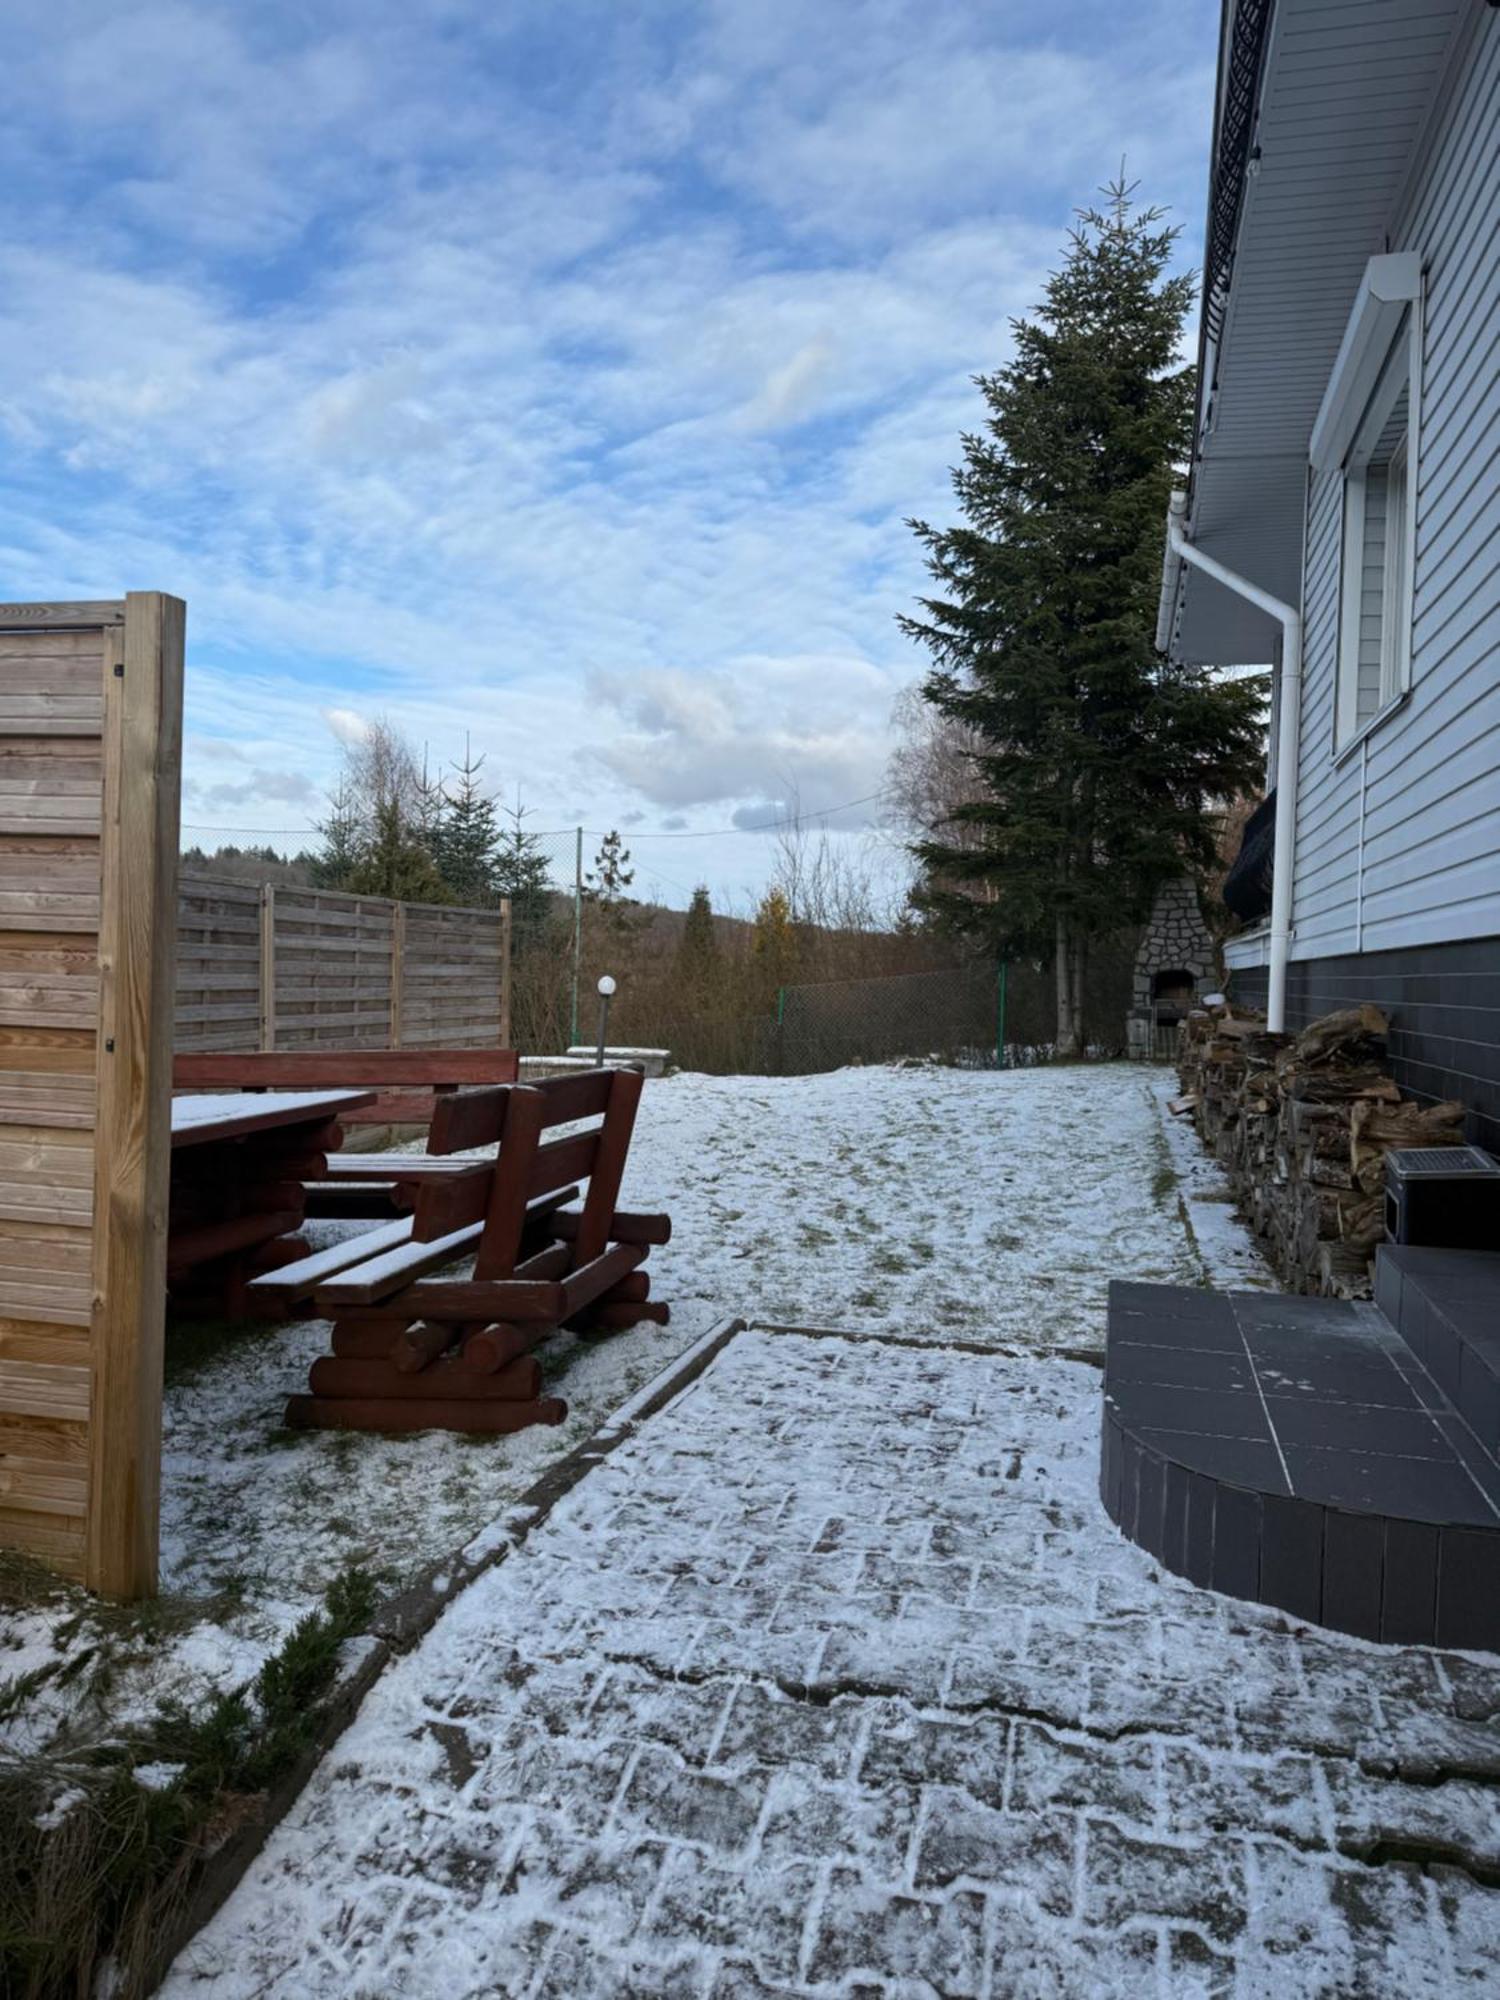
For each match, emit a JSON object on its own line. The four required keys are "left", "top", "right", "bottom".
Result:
{"left": 0, "top": 0, "right": 1218, "bottom": 902}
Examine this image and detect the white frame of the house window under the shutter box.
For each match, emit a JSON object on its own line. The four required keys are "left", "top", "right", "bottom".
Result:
{"left": 1334, "top": 322, "right": 1422, "bottom": 754}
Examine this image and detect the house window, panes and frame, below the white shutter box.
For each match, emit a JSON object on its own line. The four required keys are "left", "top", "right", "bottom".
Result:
{"left": 1338, "top": 314, "right": 1416, "bottom": 744}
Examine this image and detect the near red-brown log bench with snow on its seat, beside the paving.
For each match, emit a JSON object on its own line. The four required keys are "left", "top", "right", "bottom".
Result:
{"left": 278, "top": 1068, "right": 672, "bottom": 1432}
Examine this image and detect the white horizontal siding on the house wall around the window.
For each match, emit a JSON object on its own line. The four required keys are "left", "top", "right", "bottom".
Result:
{"left": 1296, "top": 14, "right": 1500, "bottom": 958}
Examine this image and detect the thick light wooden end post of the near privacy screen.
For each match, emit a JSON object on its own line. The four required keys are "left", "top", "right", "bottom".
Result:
{"left": 84, "top": 590, "right": 186, "bottom": 1598}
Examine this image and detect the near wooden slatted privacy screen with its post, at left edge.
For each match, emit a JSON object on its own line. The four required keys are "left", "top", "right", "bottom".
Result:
{"left": 0, "top": 592, "right": 184, "bottom": 1596}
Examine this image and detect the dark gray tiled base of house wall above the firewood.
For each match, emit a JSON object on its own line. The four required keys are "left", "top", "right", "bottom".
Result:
{"left": 1230, "top": 938, "right": 1500, "bottom": 1152}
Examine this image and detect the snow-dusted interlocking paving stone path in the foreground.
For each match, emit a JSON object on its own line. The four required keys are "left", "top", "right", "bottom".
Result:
{"left": 166, "top": 1332, "right": 1500, "bottom": 2000}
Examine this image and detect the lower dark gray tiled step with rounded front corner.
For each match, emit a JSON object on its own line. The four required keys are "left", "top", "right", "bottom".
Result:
{"left": 1100, "top": 1272, "right": 1500, "bottom": 1648}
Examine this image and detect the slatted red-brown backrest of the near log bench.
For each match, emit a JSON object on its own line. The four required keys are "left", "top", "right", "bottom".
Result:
{"left": 424, "top": 1070, "right": 642, "bottom": 1278}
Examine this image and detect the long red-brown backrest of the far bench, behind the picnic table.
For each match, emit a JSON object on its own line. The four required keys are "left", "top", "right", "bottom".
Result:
{"left": 172, "top": 1048, "right": 520, "bottom": 1124}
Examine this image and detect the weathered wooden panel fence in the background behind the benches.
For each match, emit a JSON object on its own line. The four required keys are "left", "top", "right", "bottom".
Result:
{"left": 176, "top": 874, "right": 510, "bottom": 1050}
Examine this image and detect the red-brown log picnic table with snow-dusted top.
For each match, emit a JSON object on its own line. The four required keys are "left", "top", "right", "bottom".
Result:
{"left": 166, "top": 1090, "right": 376, "bottom": 1318}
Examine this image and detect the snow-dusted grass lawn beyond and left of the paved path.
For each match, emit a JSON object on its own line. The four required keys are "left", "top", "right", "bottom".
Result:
{"left": 0, "top": 1064, "right": 1266, "bottom": 1746}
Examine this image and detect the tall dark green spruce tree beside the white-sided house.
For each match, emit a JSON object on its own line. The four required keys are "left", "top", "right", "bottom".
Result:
{"left": 902, "top": 182, "right": 1264, "bottom": 1054}
